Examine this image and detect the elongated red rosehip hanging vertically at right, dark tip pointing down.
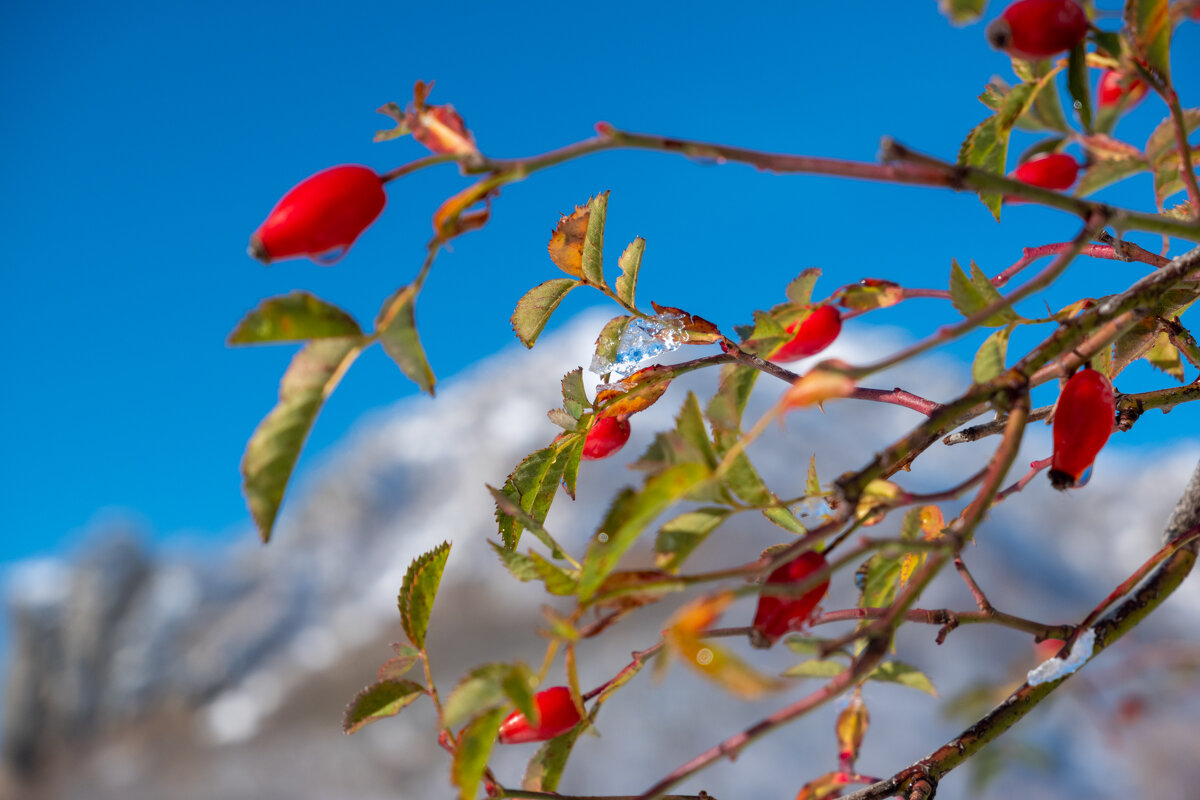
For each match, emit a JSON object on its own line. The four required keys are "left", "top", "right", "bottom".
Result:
{"left": 1050, "top": 367, "right": 1116, "bottom": 489}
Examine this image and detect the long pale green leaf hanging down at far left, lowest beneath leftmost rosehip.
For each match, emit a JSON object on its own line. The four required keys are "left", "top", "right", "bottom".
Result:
{"left": 241, "top": 337, "right": 362, "bottom": 542}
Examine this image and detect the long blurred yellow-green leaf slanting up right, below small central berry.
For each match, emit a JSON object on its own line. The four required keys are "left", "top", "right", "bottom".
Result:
{"left": 580, "top": 464, "right": 712, "bottom": 603}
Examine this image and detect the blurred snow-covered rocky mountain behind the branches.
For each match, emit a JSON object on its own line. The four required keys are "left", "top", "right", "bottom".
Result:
{"left": 0, "top": 317, "right": 1200, "bottom": 800}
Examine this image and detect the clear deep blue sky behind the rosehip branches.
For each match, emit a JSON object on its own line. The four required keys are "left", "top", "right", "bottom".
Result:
{"left": 0, "top": 0, "right": 1200, "bottom": 561}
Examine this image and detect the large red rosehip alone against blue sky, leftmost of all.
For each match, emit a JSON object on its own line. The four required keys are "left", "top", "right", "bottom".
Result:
{"left": 250, "top": 164, "right": 388, "bottom": 265}
